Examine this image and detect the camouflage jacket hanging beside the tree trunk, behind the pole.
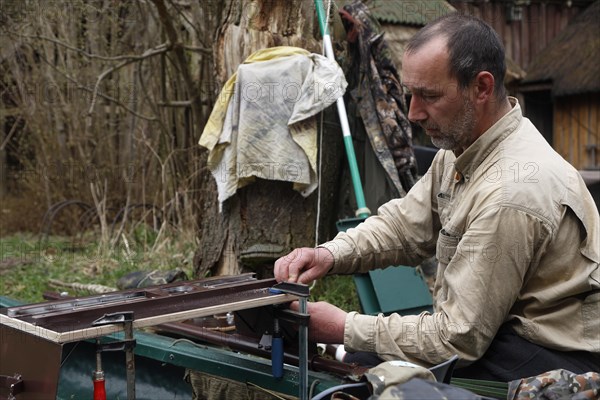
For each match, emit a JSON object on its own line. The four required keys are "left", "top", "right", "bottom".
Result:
{"left": 340, "top": 0, "right": 417, "bottom": 197}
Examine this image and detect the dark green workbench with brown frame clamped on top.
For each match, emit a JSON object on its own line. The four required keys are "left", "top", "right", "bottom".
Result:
{"left": 0, "top": 274, "right": 352, "bottom": 399}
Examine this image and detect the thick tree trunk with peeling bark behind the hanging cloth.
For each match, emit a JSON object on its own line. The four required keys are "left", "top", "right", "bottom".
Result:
{"left": 194, "top": 0, "right": 342, "bottom": 278}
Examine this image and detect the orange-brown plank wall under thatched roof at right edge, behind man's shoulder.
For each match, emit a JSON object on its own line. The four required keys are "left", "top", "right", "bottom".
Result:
{"left": 552, "top": 93, "right": 600, "bottom": 169}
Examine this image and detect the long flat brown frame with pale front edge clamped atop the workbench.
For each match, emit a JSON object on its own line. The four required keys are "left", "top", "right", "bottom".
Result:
{"left": 0, "top": 274, "right": 298, "bottom": 343}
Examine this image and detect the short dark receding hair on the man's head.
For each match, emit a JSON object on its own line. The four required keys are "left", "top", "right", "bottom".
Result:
{"left": 406, "top": 12, "right": 506, "bottom": 98}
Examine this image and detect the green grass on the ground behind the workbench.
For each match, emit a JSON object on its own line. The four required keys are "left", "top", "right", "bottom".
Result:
{"left": 0, "top": 229, "right": 359, "bottom": 311}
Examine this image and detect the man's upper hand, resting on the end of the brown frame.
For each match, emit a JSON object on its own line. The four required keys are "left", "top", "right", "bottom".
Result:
{"left": 273, "top": 247, "right": 333, "bottom": 284}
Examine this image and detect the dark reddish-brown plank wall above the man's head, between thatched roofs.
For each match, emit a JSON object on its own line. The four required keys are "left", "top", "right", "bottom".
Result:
{"left": 449, "top": 0, "right": 590, "bottom": 69}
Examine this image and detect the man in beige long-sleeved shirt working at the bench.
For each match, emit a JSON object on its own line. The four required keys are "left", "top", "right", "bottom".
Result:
{"left": 274, "top": 14, "right": 600, "bottom": 381}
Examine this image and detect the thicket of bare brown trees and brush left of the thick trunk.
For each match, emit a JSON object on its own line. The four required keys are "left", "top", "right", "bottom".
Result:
{"left": 0, "top": 0, "right": 220, "bottom": 243}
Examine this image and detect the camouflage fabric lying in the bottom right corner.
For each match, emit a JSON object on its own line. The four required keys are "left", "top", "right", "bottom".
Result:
{"left": 507, "top": 369, "right": 600, "bottom": 400}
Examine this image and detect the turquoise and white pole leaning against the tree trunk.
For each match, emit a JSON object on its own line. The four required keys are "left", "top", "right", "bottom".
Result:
{"left": 315, "top": 0, "right": 371, "bottom": 218}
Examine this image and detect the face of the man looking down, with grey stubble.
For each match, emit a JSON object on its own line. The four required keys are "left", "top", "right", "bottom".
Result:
{"left": 402, "top": 38, "right": 477, "bottom": 152}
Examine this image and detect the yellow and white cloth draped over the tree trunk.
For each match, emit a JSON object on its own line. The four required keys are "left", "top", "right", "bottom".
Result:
{"left": 199, "top": 46, "right": 347, "bottom": 211}
